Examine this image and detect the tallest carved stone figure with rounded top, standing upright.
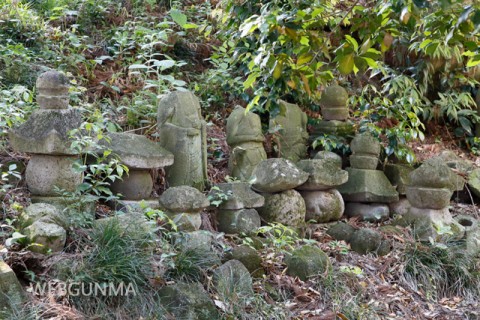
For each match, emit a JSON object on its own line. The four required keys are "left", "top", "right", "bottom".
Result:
{"left": 157, "top": 91, "right": 207, "bottom": 190}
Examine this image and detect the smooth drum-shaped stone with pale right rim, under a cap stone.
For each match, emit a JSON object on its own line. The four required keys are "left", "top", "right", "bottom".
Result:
{"left": 300, "top": 189, "right": 345, "bottom": 223}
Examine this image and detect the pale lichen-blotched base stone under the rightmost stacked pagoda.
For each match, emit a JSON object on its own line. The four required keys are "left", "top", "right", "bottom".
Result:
{"left": 403, "top": 207, "right": 465, "bottom": 241}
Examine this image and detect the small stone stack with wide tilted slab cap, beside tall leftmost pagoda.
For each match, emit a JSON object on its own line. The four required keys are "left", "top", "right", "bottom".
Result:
{"left": 100, "top": 133, "right": 173, "bottom": 209}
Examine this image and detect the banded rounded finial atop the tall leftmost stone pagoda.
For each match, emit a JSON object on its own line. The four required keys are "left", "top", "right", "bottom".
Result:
{"left": 36, "top": 71, "right": 70, "bottom": 110}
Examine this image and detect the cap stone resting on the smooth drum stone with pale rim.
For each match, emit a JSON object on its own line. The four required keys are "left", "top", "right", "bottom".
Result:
{"left": 297, "top": 159, "right": 348, "bottom": 190}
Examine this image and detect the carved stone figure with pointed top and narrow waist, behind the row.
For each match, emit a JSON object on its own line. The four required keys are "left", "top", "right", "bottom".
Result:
{"left": 227, "top": 106, "right": 267, "bottom": 181}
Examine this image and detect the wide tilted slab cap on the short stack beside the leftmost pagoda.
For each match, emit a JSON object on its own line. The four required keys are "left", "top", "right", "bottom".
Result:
{"left": 100, "top": 133, "right": 173, "bottom": 169}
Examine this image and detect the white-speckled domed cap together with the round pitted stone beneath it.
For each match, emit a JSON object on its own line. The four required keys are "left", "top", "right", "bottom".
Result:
{"left": 252, "top": 158, "right": 309, "bottom": 228}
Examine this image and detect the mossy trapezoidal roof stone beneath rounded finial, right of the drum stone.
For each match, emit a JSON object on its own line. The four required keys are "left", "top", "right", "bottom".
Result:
{"left": 338, "top": 168, "right": 398, "bottom": 203}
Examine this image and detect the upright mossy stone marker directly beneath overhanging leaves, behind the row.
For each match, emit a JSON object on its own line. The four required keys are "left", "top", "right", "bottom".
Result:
{"left": 269, "top": 100, "right": 308, "bottom": 163}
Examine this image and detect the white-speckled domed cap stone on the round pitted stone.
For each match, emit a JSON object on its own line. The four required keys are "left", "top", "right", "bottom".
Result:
{"left": 252, "top": 158, "right": 309, "bottom": 192}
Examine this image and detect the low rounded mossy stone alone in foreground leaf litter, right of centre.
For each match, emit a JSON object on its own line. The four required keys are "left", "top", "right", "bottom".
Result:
{"left": 285, "top": 245, "right": 332, "bottom": 281}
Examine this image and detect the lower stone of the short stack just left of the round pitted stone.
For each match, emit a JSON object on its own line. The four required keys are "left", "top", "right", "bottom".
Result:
{"left": 217, "top": 209, "right": 261, "bottom": 235}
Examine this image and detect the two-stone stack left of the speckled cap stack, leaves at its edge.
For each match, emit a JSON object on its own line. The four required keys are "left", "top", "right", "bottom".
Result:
{"left": 209, "top": 182, "right": 265, "bottom": 235}
